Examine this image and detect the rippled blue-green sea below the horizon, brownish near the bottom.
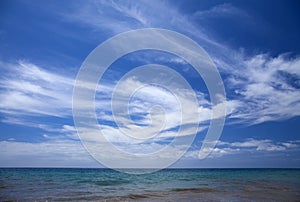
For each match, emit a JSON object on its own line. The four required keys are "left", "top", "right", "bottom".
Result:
{"left": 0, "top": 168, "right": 300, "bottom": 201}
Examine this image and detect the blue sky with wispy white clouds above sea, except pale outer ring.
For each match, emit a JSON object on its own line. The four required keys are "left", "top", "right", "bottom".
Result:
{"left": 0, "top": 0, "right": 300, "bottom": 168}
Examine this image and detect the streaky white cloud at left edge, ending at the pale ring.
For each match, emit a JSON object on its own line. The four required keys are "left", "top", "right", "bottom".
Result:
{"left": 0, "top": 61, "right": 73, "bottom": 117}
